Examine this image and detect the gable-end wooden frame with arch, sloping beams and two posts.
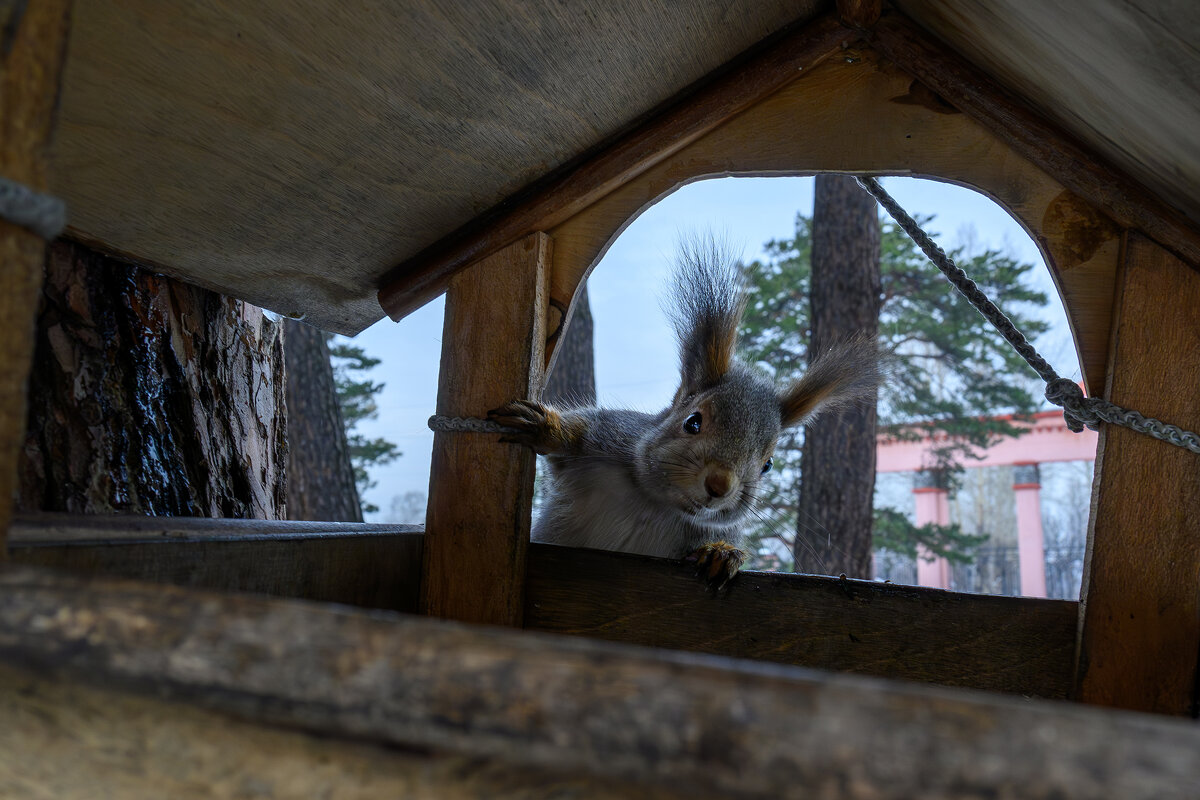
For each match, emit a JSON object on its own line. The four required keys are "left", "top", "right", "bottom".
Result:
{"left": 412, "top": 16, "right": 1200, "bottom": 714}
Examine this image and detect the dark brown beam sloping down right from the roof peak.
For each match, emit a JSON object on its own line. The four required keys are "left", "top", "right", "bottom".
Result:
{"left": 871, "top": 13, "right": 1200, "bottom": 269}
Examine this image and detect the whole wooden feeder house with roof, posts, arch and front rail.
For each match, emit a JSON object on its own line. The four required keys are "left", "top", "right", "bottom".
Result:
{"left": 0, "top": 0, "right": 1200, "bottom": 798}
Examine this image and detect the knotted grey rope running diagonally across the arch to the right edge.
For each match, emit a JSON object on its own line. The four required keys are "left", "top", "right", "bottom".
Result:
{"left": 858, "top": 178, "right": 1200, "bottom": 453}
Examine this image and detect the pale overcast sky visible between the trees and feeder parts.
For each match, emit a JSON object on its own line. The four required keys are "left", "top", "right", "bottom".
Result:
{"left": 345, "top": 178, "right": 1080, "bottom": 522}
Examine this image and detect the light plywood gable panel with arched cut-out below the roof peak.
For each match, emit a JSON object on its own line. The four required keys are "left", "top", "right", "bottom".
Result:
{"left": 551, "top": 49, "right": 1121, "bottom": 391}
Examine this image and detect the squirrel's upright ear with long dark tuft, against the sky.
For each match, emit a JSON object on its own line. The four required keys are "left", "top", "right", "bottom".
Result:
{"left": 670, "top": 234, "right": 745, "bottom": 395}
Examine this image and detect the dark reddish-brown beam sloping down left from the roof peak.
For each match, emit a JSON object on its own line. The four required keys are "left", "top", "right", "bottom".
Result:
{"left": 379, "top": 17, "right": 858, "bottom": 319}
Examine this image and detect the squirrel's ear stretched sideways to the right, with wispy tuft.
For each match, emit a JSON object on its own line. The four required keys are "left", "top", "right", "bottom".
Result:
{"left": 779, "top": 336, "right": 883, "bottom": 428}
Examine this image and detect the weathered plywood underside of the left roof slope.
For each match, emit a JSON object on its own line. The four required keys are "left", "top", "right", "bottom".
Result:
{"left": 54, "top": 0, "right": 821, "bottom": 335}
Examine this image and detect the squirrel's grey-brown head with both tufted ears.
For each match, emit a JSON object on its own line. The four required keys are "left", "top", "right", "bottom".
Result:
{"left": 637, "top": 241, "right": 880, "bottom": 527}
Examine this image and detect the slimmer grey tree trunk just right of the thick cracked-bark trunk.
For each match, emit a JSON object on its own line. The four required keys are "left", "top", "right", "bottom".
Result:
{"left": 283, "top": 319, "right": 362, "bottom": 522}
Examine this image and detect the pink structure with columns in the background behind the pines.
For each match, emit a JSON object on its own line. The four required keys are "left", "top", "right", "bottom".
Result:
{"left": 876, "top": 410, "right": 1097, "bottom": 597}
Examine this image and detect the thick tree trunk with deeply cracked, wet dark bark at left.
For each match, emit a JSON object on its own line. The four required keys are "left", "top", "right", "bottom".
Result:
{"left": 18, "top": 242, "right": 287, "bottom": 519}
